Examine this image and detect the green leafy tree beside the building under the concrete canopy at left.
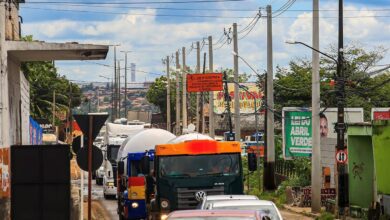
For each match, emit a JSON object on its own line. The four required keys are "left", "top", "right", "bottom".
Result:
{"left": 21, "top": 36, "right": 81, "bottom": 123}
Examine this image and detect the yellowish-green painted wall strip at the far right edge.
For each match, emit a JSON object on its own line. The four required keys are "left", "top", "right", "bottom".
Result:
{"left": 372, "top": 120, "right": 390, "bottom": 195}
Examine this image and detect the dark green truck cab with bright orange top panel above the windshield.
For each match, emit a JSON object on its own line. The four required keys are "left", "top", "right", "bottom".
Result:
{"left": 149, "top": 140, "right": 244, "bottom": 219}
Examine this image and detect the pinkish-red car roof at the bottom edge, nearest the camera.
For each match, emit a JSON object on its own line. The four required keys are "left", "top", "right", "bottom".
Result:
{"left": 169, "top": 209, "right": 261, "bottom": 218}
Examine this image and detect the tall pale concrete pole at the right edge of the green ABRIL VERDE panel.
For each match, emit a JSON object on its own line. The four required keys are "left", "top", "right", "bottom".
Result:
{"left": 311, "top": 0, "right": 322, "bottom": 213}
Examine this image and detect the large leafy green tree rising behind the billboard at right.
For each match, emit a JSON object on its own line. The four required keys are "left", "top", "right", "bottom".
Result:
{"left": 274, "top": 46, "right": 390, "bottom": 120}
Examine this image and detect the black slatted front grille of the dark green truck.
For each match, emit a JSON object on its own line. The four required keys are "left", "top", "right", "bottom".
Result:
{"left": 177, "top": 186, "right": 224, "bottom": 210}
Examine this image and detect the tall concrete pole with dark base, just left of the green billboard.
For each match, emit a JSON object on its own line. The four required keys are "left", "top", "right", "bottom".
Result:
{"left": 263, "top": 5, "right": 276, "bottom": 190}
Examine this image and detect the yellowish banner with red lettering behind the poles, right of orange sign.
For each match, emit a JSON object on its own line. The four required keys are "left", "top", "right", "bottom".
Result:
{"left": 214, "top": 83, "right": 263, "bottom": 114}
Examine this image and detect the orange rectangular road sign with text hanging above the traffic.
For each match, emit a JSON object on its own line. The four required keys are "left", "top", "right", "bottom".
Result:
{"left": 187, "top": 73, "right": 223, "bottom": 92}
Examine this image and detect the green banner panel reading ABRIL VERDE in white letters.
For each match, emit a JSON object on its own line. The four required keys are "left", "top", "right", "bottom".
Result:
{"left": 283, "top": 111, "right": 312, "bottom": 158}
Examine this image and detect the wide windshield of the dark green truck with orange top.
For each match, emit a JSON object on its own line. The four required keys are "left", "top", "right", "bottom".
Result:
{"left": 159, "top": 154, "right": 240, "bottom": 177}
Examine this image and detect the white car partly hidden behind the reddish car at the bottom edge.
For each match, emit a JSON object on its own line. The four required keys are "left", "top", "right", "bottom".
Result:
{"left": 206, "top": 200, "right": 283, "bottom": 220}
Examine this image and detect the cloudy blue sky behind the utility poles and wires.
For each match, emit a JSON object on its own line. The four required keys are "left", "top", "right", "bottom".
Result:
{"left": 20, "top": 0, "right": 390, "bottom": 82}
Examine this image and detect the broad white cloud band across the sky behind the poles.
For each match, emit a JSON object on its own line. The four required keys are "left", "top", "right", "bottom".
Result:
{"left": 23, "top": 4, "right": 390, "bottom": 80}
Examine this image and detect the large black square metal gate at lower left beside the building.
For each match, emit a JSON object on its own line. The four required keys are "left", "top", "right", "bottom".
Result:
{"left": 11, "top": 145, "right": 70, "bottom": 220}
